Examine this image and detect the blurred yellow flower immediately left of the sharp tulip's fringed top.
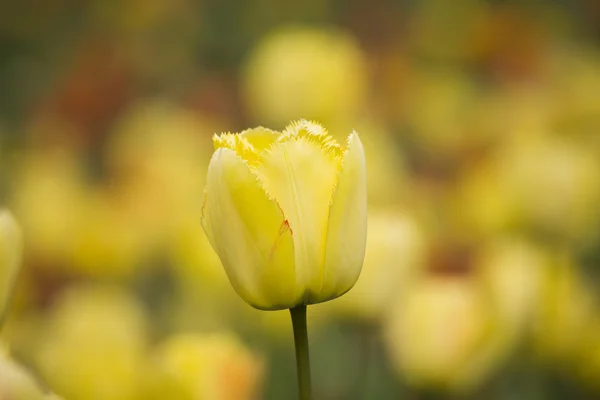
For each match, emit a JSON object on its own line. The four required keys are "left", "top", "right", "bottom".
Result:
{"left": 106, "top": 100, "right": 218, "bottom": 223}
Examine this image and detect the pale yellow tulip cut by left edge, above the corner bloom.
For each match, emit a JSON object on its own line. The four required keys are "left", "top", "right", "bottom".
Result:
{"left": 0, "top": 210, "right": 23, "bottom": 320}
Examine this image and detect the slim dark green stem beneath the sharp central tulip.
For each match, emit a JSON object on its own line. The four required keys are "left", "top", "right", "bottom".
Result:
{"left": 290, "top": 306, "right": 312, "bottom": 400}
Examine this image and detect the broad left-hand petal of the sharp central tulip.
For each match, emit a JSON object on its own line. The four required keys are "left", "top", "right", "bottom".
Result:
{"left": 202, "top": 148, "right": 301, "bottom": 309}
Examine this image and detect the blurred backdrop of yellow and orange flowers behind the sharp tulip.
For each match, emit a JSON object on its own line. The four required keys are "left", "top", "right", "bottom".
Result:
{"left": 0, "top": 0, "right": 600, "bottom": 400}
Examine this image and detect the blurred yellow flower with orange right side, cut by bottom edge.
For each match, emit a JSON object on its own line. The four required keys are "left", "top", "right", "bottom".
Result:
{"left": 149, "top": 333, "right": 263, "bottom": 400}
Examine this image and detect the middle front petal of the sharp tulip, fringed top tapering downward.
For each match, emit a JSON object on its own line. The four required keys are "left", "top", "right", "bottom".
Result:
{"left": 255, "top": 138, "right": 339, "bottom": 304}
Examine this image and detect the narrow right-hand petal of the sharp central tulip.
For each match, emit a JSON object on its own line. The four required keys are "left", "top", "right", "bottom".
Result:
{"left": 318, "top": 132, "right": 367, "bottom": 301}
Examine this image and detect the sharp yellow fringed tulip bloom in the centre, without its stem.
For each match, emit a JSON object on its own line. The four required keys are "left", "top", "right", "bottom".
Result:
{"left": 202, "top": 120, "right": 367, "bottom": 310}
